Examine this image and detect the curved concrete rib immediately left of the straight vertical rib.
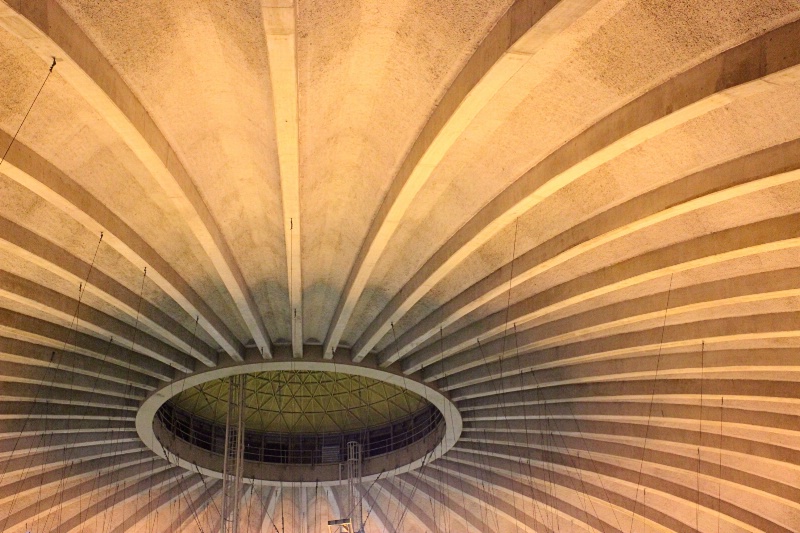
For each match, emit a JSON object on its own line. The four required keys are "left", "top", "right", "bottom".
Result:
{"left": 0, "top": 2, "right": 272, "bottom": 360}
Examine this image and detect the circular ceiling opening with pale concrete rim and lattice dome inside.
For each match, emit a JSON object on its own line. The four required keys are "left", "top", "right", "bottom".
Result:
{"left": 137, "top": 361, "right": 461, "bottom": 486}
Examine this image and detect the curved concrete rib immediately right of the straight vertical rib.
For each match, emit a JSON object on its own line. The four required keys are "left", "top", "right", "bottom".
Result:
{"left": 323, "top": 0, "right": 597, "bottom": 360}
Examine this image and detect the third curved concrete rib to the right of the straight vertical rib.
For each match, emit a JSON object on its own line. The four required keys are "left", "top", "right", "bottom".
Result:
{"left": 400, "top": 155, "right": 800, "bottom": 372}
